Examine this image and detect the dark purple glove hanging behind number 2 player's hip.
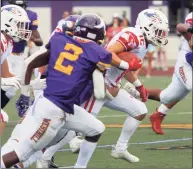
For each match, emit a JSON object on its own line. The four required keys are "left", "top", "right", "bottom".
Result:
{"left": 16, "top": 94, "right": 30, "bottom": 117}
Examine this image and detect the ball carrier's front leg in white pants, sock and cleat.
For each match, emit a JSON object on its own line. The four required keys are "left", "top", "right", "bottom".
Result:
{"left": 105, "top": 89, "right": 147, "bottom": 162}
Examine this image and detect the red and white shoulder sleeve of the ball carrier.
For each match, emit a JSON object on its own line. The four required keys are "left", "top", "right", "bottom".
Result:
{"left": 117, "top": 31, "right": 139, "bottom": 51}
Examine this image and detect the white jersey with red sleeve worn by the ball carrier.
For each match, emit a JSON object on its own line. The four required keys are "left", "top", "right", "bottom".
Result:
{"left": 105, "top": 27, "right": 147, "bottom": 86}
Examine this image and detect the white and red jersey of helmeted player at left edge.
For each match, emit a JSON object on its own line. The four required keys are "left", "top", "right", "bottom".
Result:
{"left": 1, "top": 33, "right": 13, "bottom": 64}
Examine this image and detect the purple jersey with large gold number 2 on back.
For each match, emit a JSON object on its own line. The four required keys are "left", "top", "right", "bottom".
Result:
{"left": 44, "top": 33, "right": 112, "bottom": 114}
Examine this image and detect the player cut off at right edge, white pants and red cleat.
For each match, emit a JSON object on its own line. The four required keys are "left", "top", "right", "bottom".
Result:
{"left": 149, "top": 12, "right": 193, "bottom": 134}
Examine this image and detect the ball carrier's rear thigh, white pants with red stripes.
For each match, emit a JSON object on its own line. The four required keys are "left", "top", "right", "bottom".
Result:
{"left": 81, "top": 95, "right": 106, "bottom": 117}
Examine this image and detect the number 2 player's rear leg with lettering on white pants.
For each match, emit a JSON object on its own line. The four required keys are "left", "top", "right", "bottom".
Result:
{"left": 1, "top": 95, "right": 64, "bottom": 168}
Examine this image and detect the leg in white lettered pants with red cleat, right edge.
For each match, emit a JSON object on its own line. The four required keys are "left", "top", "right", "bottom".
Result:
{"left": 150, "top": 51, "right": 192, "bottom": 134}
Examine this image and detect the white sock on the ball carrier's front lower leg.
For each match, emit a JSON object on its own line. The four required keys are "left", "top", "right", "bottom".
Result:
{"left": 116, "top": 116, "right": 141, "bottom": 152}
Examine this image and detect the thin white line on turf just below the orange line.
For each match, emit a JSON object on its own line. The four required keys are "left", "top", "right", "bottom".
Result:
{"left": 57, "top": 138, "right": 193, "bottom": 152}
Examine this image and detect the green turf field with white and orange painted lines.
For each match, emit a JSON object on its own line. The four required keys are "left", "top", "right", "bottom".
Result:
{"left": 2, "top": 77, "right": 192, "bottom": 168}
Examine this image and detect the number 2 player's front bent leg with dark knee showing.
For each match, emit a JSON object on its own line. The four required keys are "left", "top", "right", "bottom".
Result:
{"left": 64, "top": 105, "right": 105, "bottom": 168}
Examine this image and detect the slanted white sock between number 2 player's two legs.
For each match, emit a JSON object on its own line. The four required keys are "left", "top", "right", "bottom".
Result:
{"left": 42, "top": 130, "right": 76, "bottom": 161}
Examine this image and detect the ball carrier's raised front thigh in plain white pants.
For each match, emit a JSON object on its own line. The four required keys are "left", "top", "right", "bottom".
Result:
{"left": 105, "top": 89, "right": 147, "bottom": 117}
